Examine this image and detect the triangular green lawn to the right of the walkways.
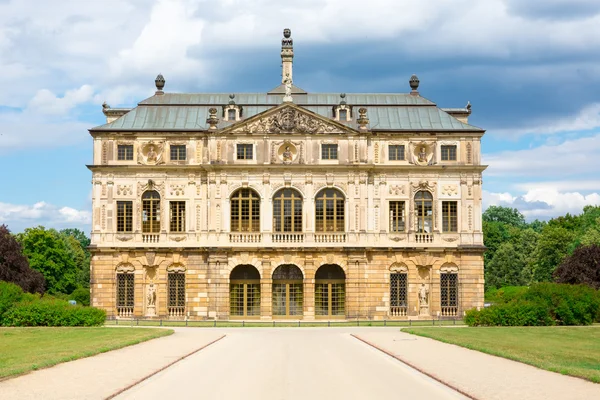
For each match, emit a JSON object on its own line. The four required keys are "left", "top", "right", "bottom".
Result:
{"left": 402, "top": 326, "right": 600, "bottom": 383}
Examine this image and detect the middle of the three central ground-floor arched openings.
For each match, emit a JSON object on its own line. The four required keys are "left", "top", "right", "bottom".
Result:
{"left": 273, "top": 264, "right": 304, "bottom": 318}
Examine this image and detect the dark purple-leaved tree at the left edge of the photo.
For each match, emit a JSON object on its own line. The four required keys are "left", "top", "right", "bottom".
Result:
{"left": 0, "top": 225, "right": 46, "bottom": 293}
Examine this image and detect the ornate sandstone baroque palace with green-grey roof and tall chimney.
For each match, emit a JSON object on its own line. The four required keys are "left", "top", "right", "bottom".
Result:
{"left": 88, "top": 29, "right": 485, "bottom": 320}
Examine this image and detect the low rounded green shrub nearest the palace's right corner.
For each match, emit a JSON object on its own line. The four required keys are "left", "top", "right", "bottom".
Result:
{"left": 465, "top": 302, "right": 554, "bottom": 326}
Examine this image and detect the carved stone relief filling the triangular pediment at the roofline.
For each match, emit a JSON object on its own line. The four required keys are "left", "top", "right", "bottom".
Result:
{"left": 231, "top": 107, "right": 345, "bottom": 134}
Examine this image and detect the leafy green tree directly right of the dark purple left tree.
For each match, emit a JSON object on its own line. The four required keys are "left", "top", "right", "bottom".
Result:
{"left": 17, "top": 226, "right": 78, "bottom": 294}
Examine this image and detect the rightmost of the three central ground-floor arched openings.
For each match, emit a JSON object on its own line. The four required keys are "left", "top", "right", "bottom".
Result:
{"left": 315, "top": 264, "right": 346, "bottom": 317}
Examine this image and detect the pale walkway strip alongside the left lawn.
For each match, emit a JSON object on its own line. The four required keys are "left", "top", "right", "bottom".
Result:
{"left": 0, "top": 328, "right": 223, "bottom": 400}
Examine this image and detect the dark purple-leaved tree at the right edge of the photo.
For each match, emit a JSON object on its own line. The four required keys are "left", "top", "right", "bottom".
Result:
{"left": 554, "top": 245, "right": 600, "bottom": 289}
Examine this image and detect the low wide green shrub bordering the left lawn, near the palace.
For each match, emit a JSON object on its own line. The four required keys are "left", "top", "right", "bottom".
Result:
{"left": 2, "top": 300, "right": 106, "bottom": 326}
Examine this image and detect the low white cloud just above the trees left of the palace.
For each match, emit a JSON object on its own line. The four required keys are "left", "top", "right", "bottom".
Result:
{"left": 0, "top": 201, "right": 92, "bottom": 231}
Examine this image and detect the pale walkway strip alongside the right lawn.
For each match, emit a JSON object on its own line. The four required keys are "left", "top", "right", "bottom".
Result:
{"left": 356, "top": 328, "right": 600, "bottom": 400}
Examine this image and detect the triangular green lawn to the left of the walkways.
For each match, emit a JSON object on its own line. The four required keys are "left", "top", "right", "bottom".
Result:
{"left": 0, "top": 327, "right": 173, "bottom": 379}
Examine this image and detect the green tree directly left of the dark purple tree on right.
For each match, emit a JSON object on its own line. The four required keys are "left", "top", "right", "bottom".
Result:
{"left": 532, "top": 227, "right": 575, "bottom": 282}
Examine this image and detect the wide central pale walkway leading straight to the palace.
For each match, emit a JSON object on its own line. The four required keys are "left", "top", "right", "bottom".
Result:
{"left": 116, "top": 328, "right": 465, "bottom": 400}
